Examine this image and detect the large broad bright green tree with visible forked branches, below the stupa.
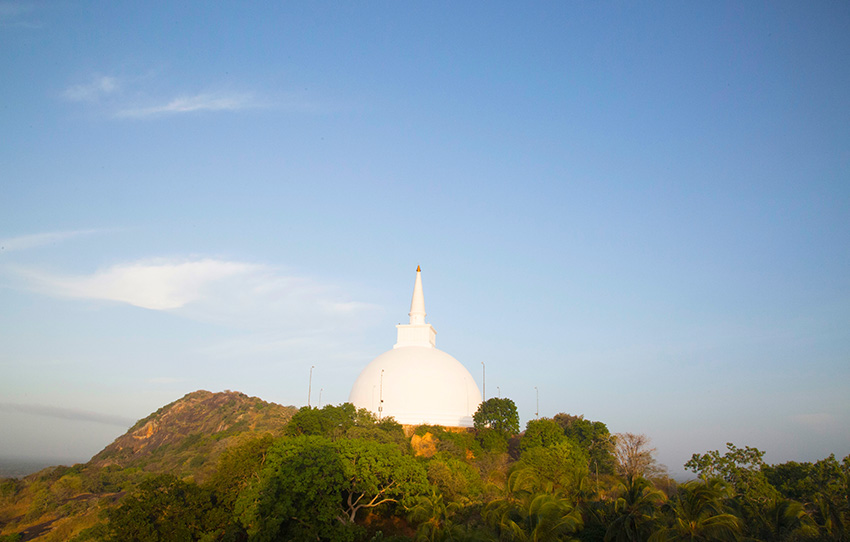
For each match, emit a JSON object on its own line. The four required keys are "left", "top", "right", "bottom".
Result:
{"left": 236, "top": 436, "right": 428, "bottom": 542}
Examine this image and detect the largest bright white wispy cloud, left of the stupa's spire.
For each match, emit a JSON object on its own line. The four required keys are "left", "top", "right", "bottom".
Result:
{"left": 12, "top": 258, "right": 376, "bottom": 334}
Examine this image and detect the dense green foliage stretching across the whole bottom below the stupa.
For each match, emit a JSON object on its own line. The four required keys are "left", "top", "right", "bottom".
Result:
{"left": 0, "top": 399, "right": 850, "bottom": 542}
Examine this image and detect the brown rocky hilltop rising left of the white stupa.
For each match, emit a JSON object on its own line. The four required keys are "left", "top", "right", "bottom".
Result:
{"left": 89, "top": 390, "right": 297, "bottom": 474}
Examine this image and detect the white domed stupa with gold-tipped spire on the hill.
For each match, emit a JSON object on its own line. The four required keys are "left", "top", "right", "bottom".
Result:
{"left": 348, "top": 267, "right": 481, "bottom": 427}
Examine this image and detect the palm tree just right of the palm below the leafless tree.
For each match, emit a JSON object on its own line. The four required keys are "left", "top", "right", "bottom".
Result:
{"left": 650, "top": 480, "right": 741, "bottom": 542}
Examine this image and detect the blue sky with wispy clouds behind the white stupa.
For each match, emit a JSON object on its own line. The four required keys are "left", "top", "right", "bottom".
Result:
{"left": 0, "top": 1, "right": 850, "bottom": 472}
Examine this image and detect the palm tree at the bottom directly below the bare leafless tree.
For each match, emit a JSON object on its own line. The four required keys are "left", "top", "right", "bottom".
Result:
{"left": 605, "top": 477, "right": 665, "bottom": 542}
